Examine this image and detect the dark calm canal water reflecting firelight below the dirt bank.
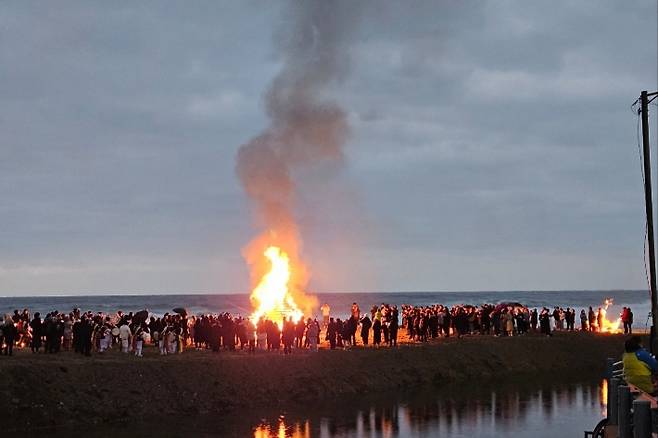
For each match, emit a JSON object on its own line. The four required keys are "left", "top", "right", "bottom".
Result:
{"left": 56, "top": 381, "right": 606, "bottom": 438}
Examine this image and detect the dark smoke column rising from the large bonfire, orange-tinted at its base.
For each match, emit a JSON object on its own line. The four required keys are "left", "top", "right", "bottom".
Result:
{"left": 237, "top": 0, "right": 359, "bottom": 308}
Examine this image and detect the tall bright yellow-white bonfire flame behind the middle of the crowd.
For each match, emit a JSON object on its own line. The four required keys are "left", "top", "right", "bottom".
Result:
{"left": 250, "top": 246, "right": 304, "bottom": 323}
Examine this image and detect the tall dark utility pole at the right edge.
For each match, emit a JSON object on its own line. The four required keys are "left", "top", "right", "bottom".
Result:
{"left": 640, "top": 91, "right": 658, "bottom": 354}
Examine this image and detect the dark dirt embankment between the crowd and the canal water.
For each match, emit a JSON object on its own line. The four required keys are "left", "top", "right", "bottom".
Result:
{"left": 0, "top": 333, "right": 623, "bottom": 430}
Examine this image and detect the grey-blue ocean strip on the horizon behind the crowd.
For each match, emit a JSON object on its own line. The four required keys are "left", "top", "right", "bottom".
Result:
{"left": 0, "top": 290, "right": 651, "bottom": 328}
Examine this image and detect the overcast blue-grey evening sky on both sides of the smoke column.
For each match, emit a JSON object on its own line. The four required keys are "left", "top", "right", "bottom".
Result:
{"left": 0, "top": 0, "right": 658, "bottom": 296}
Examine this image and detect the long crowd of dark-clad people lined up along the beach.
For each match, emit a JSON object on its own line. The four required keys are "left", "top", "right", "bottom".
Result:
{"left": 0, "top": 303, "right": 633, "bottom": 357}
